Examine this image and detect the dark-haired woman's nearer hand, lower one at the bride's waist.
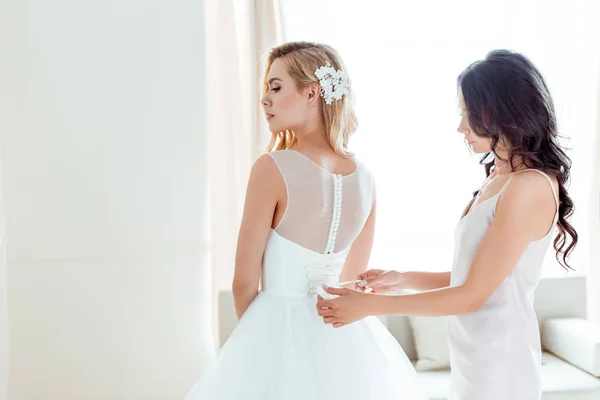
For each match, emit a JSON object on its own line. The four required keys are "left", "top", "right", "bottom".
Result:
{"left": 317, "top": 287, "right": 375, "bottom": 328}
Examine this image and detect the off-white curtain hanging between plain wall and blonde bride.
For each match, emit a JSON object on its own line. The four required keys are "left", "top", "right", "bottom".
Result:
{"left": 206, "top": 0, "right": 282, "bottom": 292}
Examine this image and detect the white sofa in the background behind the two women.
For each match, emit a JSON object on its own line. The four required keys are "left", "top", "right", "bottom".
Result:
{"left": 218, "top": 276, "right": 600, "bottom": 400}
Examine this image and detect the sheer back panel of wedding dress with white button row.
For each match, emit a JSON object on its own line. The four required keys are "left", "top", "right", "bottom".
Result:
{"left": 269, "top": 150, "right": 374, "bottom": 254}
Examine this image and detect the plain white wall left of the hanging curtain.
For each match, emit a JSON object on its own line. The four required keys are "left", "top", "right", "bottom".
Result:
{"left": 0, "top": 0, "right": 214, "bottom": 400}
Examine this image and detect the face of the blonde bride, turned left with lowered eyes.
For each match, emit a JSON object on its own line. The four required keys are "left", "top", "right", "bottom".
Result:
{"left": 261, "top": 59, "right": 311, "bottom": 132}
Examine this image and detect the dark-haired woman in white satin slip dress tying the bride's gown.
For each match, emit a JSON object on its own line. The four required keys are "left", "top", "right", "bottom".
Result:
{"left": 317, "top": 50, "right": 577, "bottom": 400}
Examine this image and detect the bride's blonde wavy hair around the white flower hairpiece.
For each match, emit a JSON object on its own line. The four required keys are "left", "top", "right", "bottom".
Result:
{"left": 264, "top": 42, "right": 358, "bottom": 158}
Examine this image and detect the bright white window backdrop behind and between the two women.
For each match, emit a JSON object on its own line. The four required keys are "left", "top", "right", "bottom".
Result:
{"left": 281, "top": 0, "right": 600, "bottom": 274}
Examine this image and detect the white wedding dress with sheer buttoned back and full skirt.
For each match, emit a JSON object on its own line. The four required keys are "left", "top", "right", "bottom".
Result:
{"left": 186, "top": 150, "right": 427, "bottom": 400}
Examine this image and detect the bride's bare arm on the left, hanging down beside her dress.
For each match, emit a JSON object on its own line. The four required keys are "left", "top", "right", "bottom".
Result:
{"left": 232, "top": 155, "right": 285, "bottom": 318}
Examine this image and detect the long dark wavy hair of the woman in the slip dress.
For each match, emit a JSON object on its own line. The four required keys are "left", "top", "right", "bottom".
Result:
{"left": 458, "top": 50, "right": 578, "bottom": 269}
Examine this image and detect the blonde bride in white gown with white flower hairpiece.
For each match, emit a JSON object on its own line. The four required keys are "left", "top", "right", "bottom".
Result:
{"left": 186, "top": 42, "right": 427, "bottom": 400}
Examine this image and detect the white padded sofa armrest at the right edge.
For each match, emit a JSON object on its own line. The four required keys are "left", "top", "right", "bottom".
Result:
{"left": 542, "top": 318, "right": 600, "bottom": 377}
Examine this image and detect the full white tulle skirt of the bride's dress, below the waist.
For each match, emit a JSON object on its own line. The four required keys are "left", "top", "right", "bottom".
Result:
{"left": 186, "top": 292, "right": 427, "bottom": 400}
